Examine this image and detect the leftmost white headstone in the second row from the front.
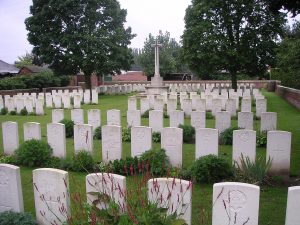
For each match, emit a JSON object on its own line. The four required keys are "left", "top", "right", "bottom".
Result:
{"left": 2, "top": 121, "right": 19, "bottom": 155}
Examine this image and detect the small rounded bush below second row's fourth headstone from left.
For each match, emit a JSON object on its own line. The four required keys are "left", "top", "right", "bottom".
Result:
{"left": 71, "top": 150, "right": 95, "bottom": 172}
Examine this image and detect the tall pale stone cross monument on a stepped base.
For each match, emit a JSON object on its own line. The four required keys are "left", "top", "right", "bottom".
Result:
{"left": 146, "top": 39, "right": 168, "bottom": 95}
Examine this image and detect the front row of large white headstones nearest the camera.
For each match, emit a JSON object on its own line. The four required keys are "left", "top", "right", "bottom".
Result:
{"left": 0, "top": 164, "right": 300, "bottom": 225}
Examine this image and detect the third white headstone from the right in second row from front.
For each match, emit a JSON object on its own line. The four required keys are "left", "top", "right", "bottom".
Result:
{"left": 195, "top": 128, "right": 219, "bottom": 159}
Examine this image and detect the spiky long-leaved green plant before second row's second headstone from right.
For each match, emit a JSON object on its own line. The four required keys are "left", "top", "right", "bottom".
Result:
{"left": 234, "top": 155, "right": 272, "bottom": 185}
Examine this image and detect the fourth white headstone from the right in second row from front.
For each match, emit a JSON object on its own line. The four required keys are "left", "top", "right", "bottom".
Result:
{"left": 161, "top": 127, "right": 183, "bottom": 167}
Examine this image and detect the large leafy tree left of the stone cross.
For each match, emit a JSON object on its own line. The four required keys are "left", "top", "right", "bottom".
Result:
{"left": 25, "top": 0, "right": 134, "bottom": 87}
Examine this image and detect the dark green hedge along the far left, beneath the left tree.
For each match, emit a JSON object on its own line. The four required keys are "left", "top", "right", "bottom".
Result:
{"left": 0, "top": 71, "right": 70, "bottom": 90}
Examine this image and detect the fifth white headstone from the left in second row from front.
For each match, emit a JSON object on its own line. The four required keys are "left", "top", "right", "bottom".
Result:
{"left": 101, "top": 125, "right": 122, "bottom": 163}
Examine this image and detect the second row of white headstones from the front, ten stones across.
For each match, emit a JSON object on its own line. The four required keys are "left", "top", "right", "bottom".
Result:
{"left": 2, "top": 122, "right": 291, "bottom": 176}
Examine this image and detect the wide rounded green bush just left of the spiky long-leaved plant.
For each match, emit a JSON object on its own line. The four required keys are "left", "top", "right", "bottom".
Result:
{"left": 189, "top": 155, "right": 233, "bottom": 183}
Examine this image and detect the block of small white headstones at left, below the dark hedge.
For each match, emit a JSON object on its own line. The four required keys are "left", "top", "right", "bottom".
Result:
{"left": 0, "top": 89, "right": 98, "bottom": 112}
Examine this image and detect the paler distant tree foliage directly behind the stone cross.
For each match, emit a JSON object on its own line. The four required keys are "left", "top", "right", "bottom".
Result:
{"left": 138, "top": 31, "right": 186, "bottom": 76}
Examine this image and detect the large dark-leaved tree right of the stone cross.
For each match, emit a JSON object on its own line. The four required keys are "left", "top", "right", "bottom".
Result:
{"left": 183, "top": 0, "right": 285, "bottom": 89}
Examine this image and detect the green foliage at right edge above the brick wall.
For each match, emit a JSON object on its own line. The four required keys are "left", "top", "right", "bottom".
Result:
{"left": 271, "top": 22, "right": 300, "bottom": 89}
